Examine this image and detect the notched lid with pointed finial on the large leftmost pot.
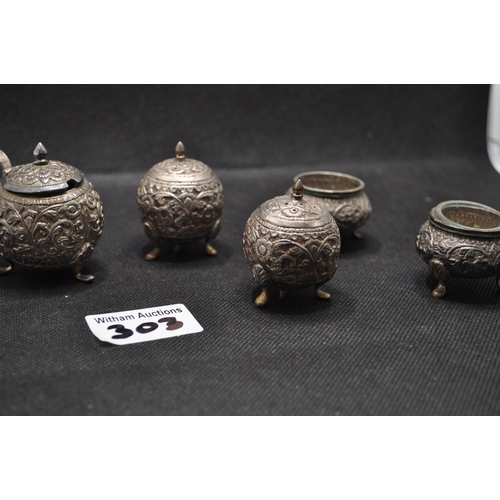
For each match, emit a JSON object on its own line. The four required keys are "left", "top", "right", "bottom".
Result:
{"left": 3, "top": 142, "right": 83, "bottom": 196}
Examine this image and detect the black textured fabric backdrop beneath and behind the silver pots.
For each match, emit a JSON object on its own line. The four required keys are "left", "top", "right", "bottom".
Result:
{"left": 0, "top": 85, "right": 500, "bottom": 415}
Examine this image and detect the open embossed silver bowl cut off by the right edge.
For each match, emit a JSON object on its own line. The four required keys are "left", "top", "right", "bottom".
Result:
{"left": 416, "top": 200, "right": 500, "bottom": 298}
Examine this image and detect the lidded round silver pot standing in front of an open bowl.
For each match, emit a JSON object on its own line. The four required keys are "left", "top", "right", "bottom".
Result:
{"left": 243, "top": 180, "right": 340, "bottom": 306}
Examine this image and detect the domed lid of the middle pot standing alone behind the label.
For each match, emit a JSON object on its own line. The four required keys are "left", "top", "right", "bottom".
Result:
{"left": 148, "top": 141, "right": 214, "bottom": 182}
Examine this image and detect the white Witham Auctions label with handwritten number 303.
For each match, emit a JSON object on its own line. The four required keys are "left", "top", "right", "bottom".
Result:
{"left": 85, "top": 304, "right": 203, "bottom": 345}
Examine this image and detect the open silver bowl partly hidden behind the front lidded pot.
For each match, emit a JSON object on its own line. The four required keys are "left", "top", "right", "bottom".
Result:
{"left": 287, "top": 171, "right": 372, "bottom": 238}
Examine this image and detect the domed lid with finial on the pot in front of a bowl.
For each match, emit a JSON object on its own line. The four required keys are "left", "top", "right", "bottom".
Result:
{"left": 256, "top": 179, "right": 333, "bottom": 228}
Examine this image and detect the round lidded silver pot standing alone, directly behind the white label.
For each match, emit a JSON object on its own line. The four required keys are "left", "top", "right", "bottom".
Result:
{"left": 137, "top": 142, "right": 224, "bottom": 260}
